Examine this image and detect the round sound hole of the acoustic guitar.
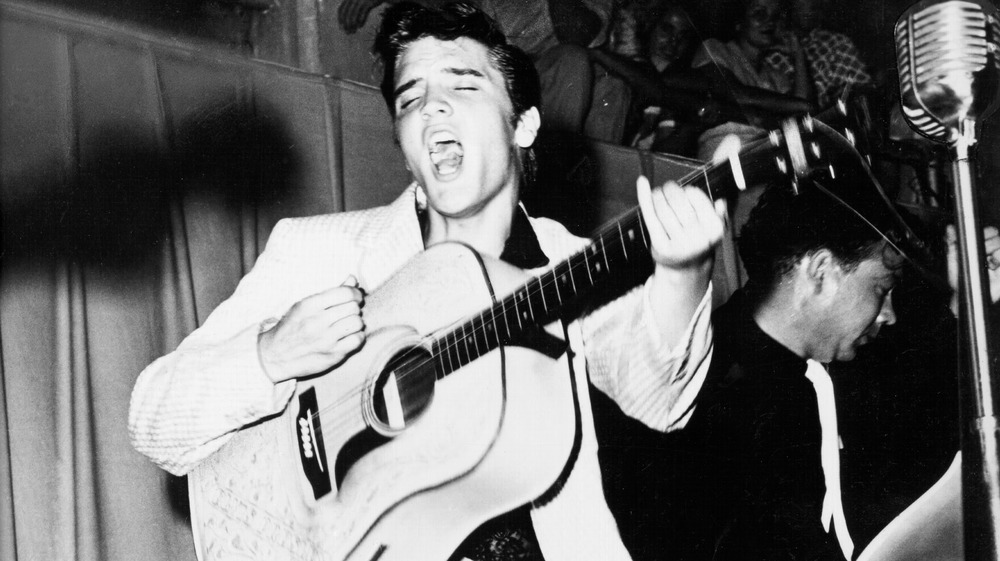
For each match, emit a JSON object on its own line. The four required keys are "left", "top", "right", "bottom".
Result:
{"left": 372, "top": 348, "right": 437, "bottom": 431}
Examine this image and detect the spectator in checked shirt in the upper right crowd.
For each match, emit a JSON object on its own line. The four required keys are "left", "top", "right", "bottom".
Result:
{"left": 766, "top": 0, "right": 872, "bottom": 110}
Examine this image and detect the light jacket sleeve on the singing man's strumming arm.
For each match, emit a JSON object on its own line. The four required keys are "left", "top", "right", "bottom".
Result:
{"left": 128, "top": 220, "right": 346, "bottom": 475}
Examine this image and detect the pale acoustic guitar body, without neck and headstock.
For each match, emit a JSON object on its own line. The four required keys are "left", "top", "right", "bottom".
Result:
{"left": 190, "top": 244, "right": 579, "bottom": 561}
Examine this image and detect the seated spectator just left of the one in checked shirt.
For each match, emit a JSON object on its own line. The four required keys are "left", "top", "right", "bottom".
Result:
{"left": 692, "top": 0, "right": 812, "bottom": 160}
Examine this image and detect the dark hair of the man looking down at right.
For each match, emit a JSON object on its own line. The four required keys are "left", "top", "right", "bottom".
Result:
{"left": 737, "top": 180, "right": 884, "bottom": 293}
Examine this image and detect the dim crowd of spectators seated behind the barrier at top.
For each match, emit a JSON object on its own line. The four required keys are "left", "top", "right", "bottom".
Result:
{"left": 338, "top": 0, "right": 929, "bottom": 180}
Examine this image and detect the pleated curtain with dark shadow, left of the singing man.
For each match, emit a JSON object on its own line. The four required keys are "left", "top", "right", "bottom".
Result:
{"left": 0, "top": 2, "right": 407, "bottom": 561}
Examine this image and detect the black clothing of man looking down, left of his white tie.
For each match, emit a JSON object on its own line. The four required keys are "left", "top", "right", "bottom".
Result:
{"left": 592, "top": 292, "right": 842, "bottom": 560}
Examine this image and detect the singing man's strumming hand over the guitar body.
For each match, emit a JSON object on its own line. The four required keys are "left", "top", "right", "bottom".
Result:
{"left": 257, "top": 276, "right": 365, "bottom": 383}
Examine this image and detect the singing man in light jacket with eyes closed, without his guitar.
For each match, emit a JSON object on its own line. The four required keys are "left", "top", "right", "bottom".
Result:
{"left": 129, "top": 4, "right": 725, "bottom": 561}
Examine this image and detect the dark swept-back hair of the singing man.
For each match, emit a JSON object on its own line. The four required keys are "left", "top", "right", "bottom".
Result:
{"left": 373, "top": 2, "right": 541, "bottom": 178}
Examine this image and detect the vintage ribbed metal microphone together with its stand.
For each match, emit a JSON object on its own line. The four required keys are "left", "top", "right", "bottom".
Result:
{"left": 895, "top": 0, "right": 1000, "bottom": 561}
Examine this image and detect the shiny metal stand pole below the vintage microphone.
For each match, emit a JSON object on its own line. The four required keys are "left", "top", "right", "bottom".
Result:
{"left": 952, "top": 117, "right": 1000, "bottom": 561}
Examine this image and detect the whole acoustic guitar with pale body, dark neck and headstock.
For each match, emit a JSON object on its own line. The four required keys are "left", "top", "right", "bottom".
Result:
{"left": 189, "top": 118, "right": 858, "bottom": 561}
